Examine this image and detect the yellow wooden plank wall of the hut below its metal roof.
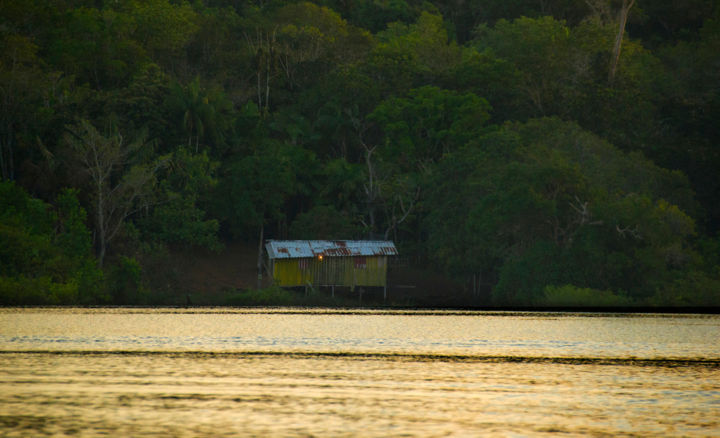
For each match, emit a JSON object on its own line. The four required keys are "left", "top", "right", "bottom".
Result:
{"left": 272, "top": 256, "right": 387, "bottom": 288}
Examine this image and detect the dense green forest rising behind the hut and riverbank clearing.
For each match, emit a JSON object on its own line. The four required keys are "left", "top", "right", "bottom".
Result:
{"left": 0, "top": 0, "right": 720, "bottom": 307}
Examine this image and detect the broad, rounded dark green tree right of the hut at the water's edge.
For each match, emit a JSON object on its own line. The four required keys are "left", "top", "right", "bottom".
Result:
{"left": 426, "top": 119, "right": 696, "bottom": 303}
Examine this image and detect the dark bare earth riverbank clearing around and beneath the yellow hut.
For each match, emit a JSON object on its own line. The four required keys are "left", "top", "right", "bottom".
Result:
{"left": 165, "top": 242, "right": 466, "bottom": 307}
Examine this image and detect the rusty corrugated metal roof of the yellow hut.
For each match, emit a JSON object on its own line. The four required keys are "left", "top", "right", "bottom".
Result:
{"left": 265, "top": 240, "right": 398, "bottom": 259}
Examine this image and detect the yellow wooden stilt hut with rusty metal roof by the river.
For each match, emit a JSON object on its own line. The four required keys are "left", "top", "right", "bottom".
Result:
{"left": 265, "top": 240, "right": 398, "bottom": 296}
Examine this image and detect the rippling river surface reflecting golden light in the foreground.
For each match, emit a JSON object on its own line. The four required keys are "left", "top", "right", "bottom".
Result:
{"left": 0, "top": 308, "right": 720, "bottom": 437}
